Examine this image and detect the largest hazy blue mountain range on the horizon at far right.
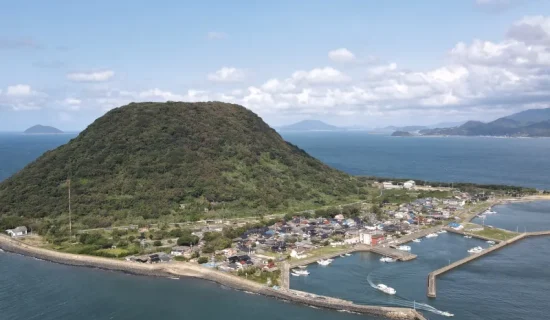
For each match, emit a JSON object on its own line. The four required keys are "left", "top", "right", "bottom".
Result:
{"left": 420, "top": 108, "right": 550, "bottom": 137}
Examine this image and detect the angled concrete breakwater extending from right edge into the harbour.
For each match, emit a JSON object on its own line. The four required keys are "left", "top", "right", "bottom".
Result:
{"left": 427, "top": 230, "right": 550, "bottom": 298}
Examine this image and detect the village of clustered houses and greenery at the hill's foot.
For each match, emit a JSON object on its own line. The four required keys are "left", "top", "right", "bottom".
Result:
{"left": 7, "top": 181, "right": 494, "bottom": 286}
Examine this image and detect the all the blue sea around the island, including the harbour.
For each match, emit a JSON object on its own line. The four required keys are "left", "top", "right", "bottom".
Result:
{"left": 0, "top": 132, "right": 550, "bottom": 320}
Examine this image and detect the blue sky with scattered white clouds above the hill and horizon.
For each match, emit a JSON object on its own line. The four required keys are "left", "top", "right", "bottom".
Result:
{"left": 0, "top": 0, "right": 550, "bottom": 131}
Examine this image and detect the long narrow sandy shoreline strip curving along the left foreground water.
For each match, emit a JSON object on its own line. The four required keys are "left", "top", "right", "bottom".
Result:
{"left": 0, "top": 235, "right": 425, "bottom": 320}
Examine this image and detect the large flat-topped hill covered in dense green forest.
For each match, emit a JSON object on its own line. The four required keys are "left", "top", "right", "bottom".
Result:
{"left": 0, "top": 102, "right": 365, "bottom": 227}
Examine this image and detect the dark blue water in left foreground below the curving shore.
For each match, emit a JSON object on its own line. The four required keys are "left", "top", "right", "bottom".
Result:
{"left": 0, "top": 253, "right": 374, "bottom": 320}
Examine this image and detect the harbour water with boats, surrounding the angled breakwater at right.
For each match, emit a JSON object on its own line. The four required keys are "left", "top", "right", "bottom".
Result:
{"left": 291, "top": 202, "right": 550, "bottom": 320}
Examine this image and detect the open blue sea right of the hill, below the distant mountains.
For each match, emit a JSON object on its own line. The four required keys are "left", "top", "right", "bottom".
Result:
{"left": 282, "top": 132, "right": 550, "bottom": 189}
